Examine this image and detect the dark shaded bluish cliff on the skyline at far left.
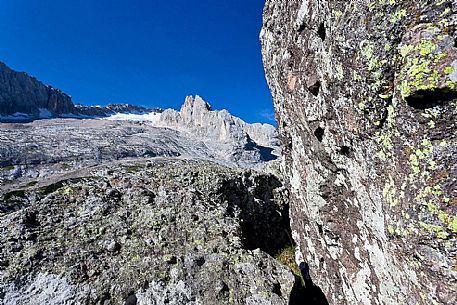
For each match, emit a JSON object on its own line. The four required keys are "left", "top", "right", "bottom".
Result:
{"left": 0, "top": 62, "right": 74, "bottom": 117}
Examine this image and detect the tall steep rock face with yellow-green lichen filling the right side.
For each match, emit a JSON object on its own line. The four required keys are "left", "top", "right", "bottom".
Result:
{"left": 261, "top": 0, "right": 457, "bottom": 304}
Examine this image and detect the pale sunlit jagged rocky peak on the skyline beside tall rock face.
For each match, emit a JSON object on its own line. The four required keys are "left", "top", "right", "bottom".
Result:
{"left": 154, "top": 96, "right": 280, "bottom": 165}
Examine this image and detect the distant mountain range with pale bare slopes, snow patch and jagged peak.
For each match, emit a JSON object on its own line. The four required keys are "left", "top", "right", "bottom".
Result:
{"left": 0, "top": 60, "right": 280, "bottom": 170}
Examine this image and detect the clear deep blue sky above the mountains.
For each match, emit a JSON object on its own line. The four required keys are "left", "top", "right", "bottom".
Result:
{"left": 0, "top": 0, "right": 273, "bottom": 122}
